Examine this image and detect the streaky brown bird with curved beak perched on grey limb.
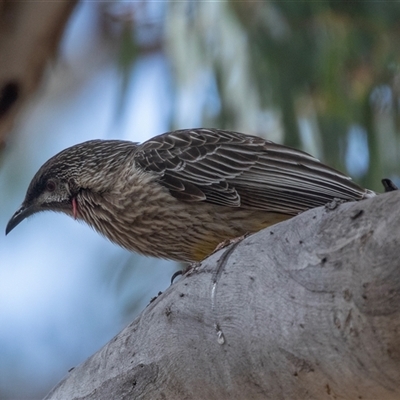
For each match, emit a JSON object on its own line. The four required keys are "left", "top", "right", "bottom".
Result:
{"left": 6, "top": 128, "right": 376, "bottom": 262}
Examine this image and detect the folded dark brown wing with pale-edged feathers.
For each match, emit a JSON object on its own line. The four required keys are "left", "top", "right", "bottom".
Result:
{"left": 135, "top": 129, "right": 372, "bottom": 214}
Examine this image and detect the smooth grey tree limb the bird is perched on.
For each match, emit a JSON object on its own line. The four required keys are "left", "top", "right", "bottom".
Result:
{"left": 46, "top": 191, "right": 400, "bottom": 400}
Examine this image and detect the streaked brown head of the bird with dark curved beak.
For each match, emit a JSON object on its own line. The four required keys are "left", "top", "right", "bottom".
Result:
{"left": 6, "top": 140, "right": 136, "bottom": 234}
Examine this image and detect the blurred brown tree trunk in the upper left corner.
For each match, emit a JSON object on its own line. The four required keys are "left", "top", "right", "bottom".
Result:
{"left": 0, "top": 0, "right": 77, "bottom": 145}
